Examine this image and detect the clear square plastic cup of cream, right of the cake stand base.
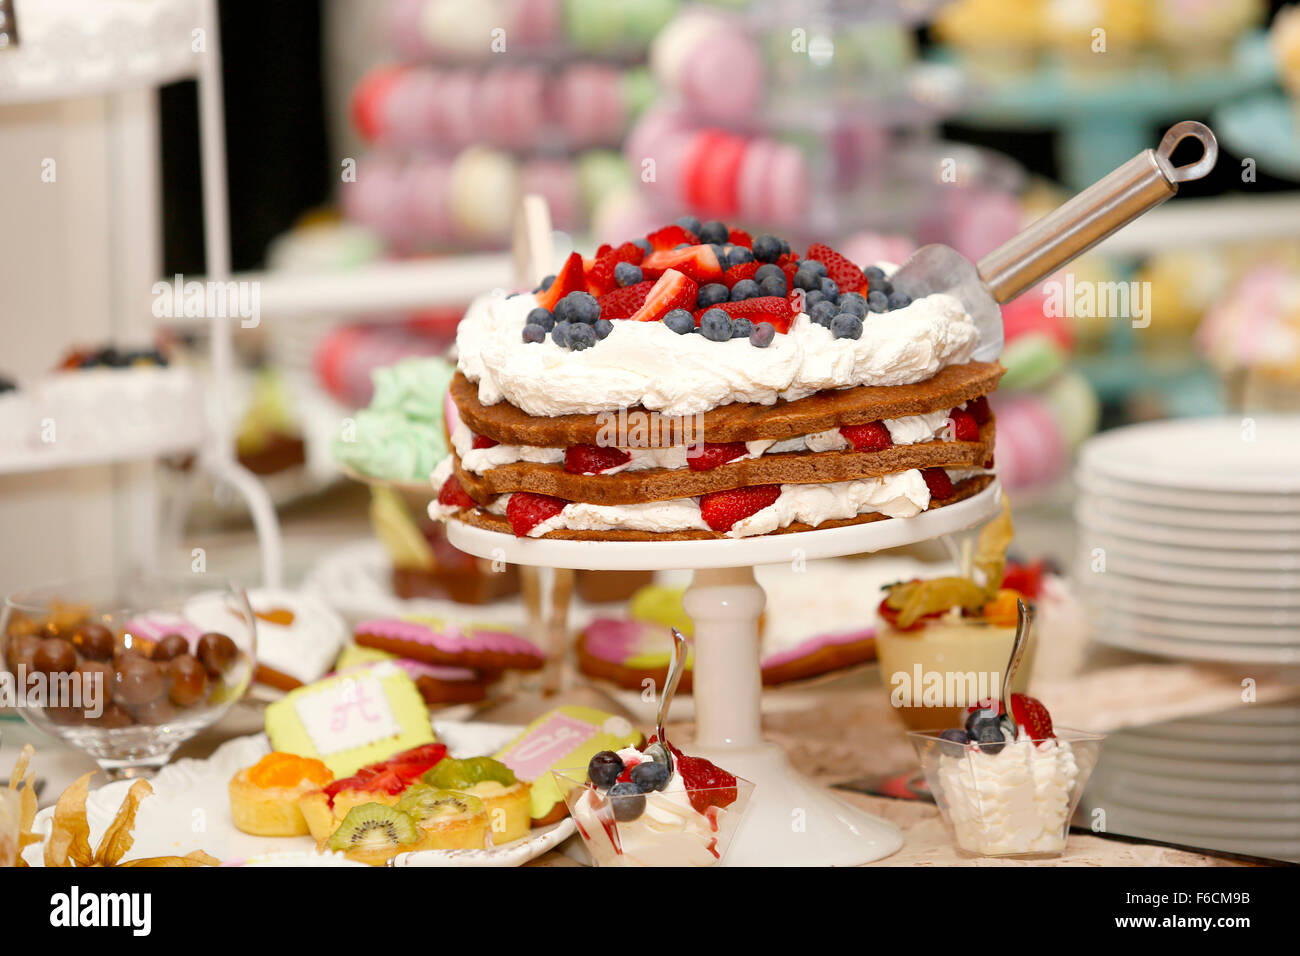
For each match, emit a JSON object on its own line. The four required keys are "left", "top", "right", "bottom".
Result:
{"left": 907, "top": 727, "right": 1105, "bottom": 858}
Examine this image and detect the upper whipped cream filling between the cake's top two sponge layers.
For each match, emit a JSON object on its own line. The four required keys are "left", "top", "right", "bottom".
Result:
{"left": 451, "top": 402, "right": 966, "bottom": 475}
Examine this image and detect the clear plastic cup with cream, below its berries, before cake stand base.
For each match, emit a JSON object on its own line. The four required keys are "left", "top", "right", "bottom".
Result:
{"left": 551, "top": 767, "right": 754, "bottom": 866}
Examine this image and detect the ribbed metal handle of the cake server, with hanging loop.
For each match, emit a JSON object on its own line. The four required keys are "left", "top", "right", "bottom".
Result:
{"left": 976, "top": 120, "right": 1218, "bottom": 302}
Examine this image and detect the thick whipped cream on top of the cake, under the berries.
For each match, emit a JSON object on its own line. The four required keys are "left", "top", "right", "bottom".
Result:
{"left": 456, "top": 277, "right": 979, "bottom": 416}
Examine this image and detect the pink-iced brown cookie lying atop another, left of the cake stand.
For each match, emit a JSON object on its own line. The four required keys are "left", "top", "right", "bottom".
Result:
{"left": 356, "top": 618, "right": 546, "bottom": 670}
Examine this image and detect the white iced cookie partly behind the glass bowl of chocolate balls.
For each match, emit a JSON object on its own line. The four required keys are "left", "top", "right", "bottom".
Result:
{"left": 185, "top": 588, "right": 347, "bottom": 691}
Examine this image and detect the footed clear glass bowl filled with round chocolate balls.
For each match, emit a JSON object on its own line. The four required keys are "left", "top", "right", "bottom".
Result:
{"left": 0, "top": 574, "right": 256, "bottom": 779}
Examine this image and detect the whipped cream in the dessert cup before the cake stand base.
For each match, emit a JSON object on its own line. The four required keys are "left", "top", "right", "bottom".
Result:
{"left": 573, "top": 748, "right": 738, "bottom": 866}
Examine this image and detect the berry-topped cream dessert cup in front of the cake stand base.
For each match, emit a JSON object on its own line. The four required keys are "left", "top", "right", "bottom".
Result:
{"left": 551, "top": 737, "right": 754, "bottom": 866}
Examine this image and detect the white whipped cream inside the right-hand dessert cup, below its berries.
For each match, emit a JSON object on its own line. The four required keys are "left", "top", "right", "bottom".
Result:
{"left": 939, "top": 734, "right": 1079, "bottom": 856}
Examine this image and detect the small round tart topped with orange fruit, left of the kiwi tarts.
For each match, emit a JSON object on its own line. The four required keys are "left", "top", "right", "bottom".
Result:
{"left": 230, "top": 750, "right": 334, "bottom": 836}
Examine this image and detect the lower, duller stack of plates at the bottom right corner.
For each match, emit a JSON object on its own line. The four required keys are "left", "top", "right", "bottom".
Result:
{"left": 1082, "top": 702, "right": 1300, "bottom": 861}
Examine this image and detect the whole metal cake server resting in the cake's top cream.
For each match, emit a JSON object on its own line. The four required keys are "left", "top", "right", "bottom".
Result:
{"left": 891, "top": 120, "right": 1218, "bottom": 362}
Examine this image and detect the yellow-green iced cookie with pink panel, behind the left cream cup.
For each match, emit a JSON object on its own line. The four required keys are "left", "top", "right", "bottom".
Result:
{"left": 493, "top": 706, "right": 641, "bottom": 826}
